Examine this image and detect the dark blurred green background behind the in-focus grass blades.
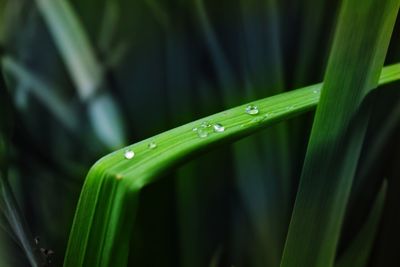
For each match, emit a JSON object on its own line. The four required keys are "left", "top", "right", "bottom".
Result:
{"left": 0, "top": 0, "right": 400, "bottom": 267}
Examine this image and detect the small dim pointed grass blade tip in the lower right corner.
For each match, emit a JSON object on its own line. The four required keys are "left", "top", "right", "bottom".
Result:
{"left": 335, "top": 180, "right": 387, "bottom": 267}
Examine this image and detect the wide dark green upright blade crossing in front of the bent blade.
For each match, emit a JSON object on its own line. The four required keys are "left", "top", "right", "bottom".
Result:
{"left": 281, "top": 0, "right": 400, "bottom": 267}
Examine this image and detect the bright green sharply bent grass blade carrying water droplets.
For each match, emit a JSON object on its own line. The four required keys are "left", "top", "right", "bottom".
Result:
{"left": 64, "top": 65, "right": 400, "bottom": 267}
